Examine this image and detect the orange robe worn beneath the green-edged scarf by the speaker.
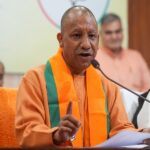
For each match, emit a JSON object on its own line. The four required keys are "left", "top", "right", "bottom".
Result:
{"left": 15, "top": 65, "right": 136, "bottom": 146}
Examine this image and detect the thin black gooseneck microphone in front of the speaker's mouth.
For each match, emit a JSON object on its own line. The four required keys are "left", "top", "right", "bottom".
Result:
{"left": 91, "top": 59, "right": 150, "bottom": 103}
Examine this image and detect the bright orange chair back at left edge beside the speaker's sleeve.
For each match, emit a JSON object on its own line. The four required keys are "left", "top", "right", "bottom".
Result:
{"left": 0, "top": 88, "right": 19, "bottom": 147}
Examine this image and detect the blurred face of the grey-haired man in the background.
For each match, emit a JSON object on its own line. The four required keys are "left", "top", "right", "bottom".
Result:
{"left": 101, "top": 20, "right": 123, "bottom": 51}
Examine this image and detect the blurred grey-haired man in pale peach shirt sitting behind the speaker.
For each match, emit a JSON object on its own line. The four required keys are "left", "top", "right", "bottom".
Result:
{"left": 96, "top": 13, "right": 150, "bottom": 92}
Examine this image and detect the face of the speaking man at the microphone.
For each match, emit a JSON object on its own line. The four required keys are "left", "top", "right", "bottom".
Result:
{"left": 57, "top": 12, "right": 99, "bottom": 74}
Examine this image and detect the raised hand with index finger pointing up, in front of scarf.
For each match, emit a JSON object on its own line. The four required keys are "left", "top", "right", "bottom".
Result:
{"left": 53, "top": 101, "right": 81, "bottom": 145}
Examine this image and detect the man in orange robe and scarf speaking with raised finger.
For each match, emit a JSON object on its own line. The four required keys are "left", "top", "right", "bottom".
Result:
{"left": 15, "top": 6, "right": 149, "bottom": 147}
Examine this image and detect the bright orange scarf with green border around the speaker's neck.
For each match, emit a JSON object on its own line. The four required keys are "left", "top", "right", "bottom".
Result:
{"left": 45, "top": 49, "right": 110, "bottom": 147}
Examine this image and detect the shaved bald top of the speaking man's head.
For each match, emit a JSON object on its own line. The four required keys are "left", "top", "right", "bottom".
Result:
{"left": 61, "top": 6, "right": 97, "bottom": 32}
